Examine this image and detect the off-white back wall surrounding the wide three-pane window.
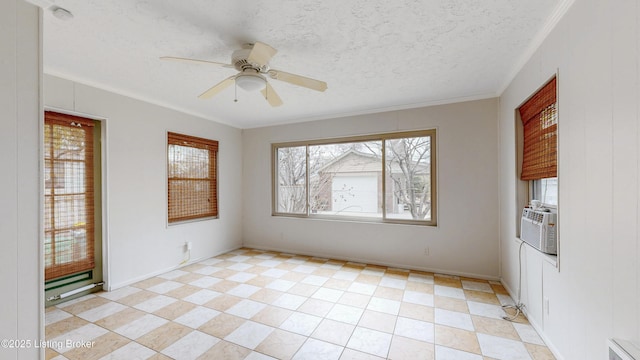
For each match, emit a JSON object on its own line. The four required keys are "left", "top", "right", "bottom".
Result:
{"left": 243, "top": 99, "right": 499, "bottom": 278}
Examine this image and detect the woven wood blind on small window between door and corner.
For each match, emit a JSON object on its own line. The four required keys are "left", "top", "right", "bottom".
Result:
{"left": 167, "top": 132, "right": 218, "bottom": 223}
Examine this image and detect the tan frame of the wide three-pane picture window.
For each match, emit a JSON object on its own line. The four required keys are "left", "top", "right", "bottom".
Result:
{"left": 271, "top": 129, "right": 438, "bottom": 227}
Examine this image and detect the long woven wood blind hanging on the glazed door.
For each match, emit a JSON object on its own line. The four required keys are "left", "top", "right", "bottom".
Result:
{"left": 44, "top": 111, "right": 95, "bottom": 280}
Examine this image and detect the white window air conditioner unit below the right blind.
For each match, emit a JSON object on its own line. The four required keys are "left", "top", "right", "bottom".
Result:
{"left": 520, "top": 208, "right": 558, "bottom": 255}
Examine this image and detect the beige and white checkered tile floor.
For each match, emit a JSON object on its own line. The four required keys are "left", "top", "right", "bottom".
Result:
{"left": 45, "top": 249, "right": 553, "bottom": 360}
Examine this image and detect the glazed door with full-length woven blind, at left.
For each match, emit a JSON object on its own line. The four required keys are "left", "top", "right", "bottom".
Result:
{"left": 44, "top": 111, "right": 102, "bottom": 306}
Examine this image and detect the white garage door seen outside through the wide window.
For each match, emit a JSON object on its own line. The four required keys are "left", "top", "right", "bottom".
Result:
{"left": 331, "top": 175, "right": 378, "bottom": 213}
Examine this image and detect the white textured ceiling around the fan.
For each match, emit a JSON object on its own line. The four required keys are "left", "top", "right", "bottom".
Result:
{"left": 44, "top": 0, "right": 562, "bottom": 128}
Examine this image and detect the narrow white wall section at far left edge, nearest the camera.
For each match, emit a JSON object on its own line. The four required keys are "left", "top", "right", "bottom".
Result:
{"left": 0, "top": 0, "right": 44, "bottom": 359}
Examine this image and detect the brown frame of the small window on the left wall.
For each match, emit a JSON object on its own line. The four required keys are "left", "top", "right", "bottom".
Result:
{"left": 166, "top": 131, "right": 220, "bottom": 226}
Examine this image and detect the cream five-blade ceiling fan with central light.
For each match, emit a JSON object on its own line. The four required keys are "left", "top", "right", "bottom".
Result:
{"left": 160, "top": 41, "right": 327, "bottom": 106}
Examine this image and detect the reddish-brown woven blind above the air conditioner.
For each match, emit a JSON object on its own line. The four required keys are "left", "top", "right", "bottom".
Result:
{"left": 519, "top": 77, "right": 558, "bottom": 180}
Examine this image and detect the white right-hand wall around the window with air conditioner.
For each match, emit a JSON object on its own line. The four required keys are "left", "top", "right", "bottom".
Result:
{"left": 499, "top": 0, "right": 640, "bottom": 359}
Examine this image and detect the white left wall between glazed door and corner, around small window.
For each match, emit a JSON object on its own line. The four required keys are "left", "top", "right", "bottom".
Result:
{"left": 44, "top": 75, "right": 242, "bottom": 289}
